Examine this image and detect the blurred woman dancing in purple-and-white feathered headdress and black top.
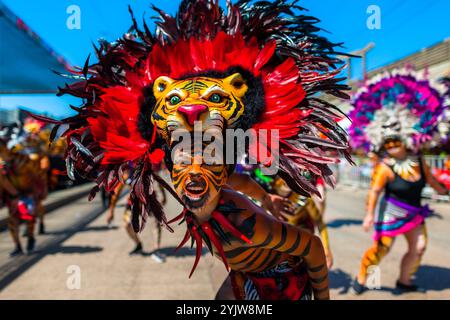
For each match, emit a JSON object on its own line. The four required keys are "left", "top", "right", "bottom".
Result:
{"left": 350, "top": 70, "right": 448, "bottom": 294}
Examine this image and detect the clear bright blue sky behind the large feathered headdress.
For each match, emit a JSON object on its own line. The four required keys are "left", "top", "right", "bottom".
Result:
{"left": 0, "top": 0, "right": 450, "bottom": 116}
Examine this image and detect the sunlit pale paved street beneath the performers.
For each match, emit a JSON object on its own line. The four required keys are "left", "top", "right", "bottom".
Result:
{"left": 0, "top": 187, "right": 450, "bottom": 300}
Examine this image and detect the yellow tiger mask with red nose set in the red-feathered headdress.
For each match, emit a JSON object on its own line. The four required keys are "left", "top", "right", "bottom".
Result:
{"left": 151, "top": 73, "right": 248, "bottom": 140}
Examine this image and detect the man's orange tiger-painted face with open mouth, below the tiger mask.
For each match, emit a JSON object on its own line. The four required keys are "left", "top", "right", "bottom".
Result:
{"left": 171, "top": 150, "right": 228, "bottom": 212}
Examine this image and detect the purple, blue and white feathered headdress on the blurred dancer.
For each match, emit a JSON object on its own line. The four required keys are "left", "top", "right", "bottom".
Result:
{"left": 349, "top": 69, "right": 447, "bottom": 151}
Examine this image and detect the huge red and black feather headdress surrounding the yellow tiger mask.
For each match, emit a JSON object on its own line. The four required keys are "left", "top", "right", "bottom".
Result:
{"left": 38, "top": 0, "right": 349, "bottom": 230}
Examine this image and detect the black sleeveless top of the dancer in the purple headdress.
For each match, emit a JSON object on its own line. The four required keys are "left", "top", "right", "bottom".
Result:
{"left": 384, "top": 157, "right": 426, "bottom": 207}
